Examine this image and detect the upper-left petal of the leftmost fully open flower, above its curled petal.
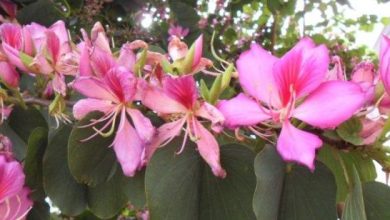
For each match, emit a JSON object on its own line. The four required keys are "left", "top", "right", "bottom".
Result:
{"left": 72, "top": 77, "right": 118, "bottom": 102}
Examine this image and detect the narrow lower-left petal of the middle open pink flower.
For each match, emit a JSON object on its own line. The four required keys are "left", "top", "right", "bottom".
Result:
{"left": 145, "top": 118, "right": 186, "bottom": 161}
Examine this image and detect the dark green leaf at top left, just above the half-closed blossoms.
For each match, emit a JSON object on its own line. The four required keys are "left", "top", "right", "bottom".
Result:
{"left": 17, "top": 0, "right": 64, "bottom": 26}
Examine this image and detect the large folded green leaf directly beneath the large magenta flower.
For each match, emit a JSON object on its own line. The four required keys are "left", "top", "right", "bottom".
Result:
{"left": 253, "top": 145, "right": 337, "bottom": 220}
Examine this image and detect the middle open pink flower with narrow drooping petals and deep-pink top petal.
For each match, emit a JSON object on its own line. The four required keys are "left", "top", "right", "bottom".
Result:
{"left": 142, "top": 76, "right": 226, "bottom": 178}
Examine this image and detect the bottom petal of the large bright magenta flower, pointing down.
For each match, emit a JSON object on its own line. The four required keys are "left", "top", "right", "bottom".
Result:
{"left": 277, "top": 121, "right": 322, "bottom": 171}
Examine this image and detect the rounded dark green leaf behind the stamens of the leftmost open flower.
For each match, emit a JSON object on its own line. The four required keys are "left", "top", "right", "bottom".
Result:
{"left": 68, "top": 113, "right": 116, "bottom": 186}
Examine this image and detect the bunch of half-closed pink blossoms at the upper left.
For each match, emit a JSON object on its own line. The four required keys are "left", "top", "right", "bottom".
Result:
{"left": 1, "top": 21, "right": 78, "bottom": 95}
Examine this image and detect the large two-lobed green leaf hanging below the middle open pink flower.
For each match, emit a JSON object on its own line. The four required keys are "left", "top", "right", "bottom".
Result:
{"left": 145, "top": 139, "right": 256, "bottom": 220}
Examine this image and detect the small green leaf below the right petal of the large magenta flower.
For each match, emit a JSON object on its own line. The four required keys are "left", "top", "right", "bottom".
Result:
{"left": 336, "top": 117, "right": 363, "bottom": 145}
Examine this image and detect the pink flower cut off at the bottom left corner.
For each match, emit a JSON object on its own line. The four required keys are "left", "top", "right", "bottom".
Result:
{"left": 0, "top": 155, "right": 32, "bottom": 220}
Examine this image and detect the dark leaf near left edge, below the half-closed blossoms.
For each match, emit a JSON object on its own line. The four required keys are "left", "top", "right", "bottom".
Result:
{"left": 8, "top": 107, "right": 48, "bottom": 143}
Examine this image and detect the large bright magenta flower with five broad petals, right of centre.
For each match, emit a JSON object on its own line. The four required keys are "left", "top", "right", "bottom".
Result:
{"left": 219, "top": 38, "right": 365, "bottom": 170}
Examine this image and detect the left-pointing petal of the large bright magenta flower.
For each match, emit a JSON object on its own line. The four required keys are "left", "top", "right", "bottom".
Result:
{"left": 218, "top": 93, "right": 270, "bottom": 128}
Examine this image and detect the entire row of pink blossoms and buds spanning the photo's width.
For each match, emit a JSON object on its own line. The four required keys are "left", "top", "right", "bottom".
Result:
{"left": 0, "top": 18, "right": 390, "bottom": 183}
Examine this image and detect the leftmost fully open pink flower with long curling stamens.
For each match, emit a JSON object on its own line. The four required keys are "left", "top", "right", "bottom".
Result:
{"left": 73, "top": 67, "right": 155, "bottom": 176}
